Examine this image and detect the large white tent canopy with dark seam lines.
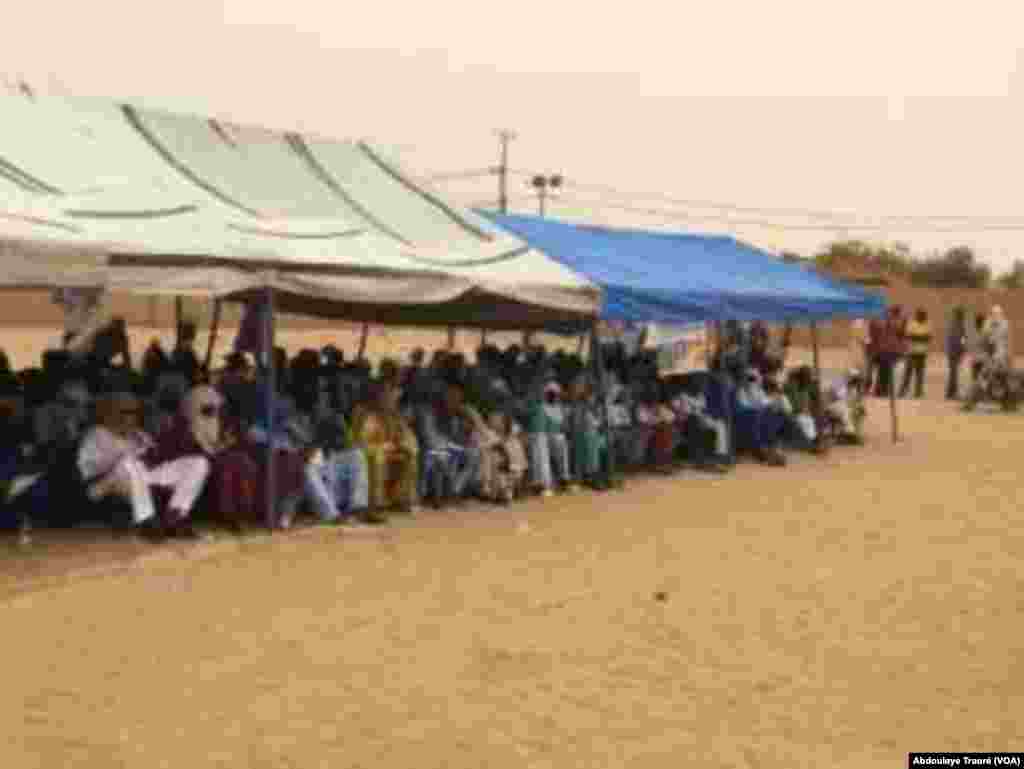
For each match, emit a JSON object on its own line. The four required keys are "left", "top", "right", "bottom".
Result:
{"left": 0, "top": 93, "right": 600, "bottom": 329}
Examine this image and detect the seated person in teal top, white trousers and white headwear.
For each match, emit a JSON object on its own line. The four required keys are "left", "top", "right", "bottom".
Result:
{"left": 526, "top": 382, "right": 575, "bottom": 497}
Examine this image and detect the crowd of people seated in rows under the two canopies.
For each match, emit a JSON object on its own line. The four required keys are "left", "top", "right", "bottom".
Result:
{"left": 0, "top": 321, "right": 863, "bottom": 541}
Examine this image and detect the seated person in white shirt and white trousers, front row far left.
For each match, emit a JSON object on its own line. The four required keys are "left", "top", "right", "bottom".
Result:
{"left": 78, "top": 393, "right": 210, "bottom": 539}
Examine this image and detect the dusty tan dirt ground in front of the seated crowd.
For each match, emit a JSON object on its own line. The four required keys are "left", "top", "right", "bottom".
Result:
{"left": 0, "top": 331, "right": 1024, "bottom": 769}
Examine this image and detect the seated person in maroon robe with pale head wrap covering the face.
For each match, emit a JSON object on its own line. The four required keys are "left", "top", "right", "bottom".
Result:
{"left": 154, "top": 385, "right": 262, "bottom": 531}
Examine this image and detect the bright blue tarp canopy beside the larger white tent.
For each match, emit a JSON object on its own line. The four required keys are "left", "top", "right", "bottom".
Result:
{"left": 480, "top": 212, "right": 886, "bottom": 325}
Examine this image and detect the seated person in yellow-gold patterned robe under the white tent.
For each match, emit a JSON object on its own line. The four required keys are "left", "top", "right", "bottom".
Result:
{"left": 352, "top": 382, "right": 420, "bottom": 521}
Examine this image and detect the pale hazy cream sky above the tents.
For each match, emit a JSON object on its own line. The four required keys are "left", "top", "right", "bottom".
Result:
{"left": 0, "top": 0, "right": 1024, "bottom": 268}
